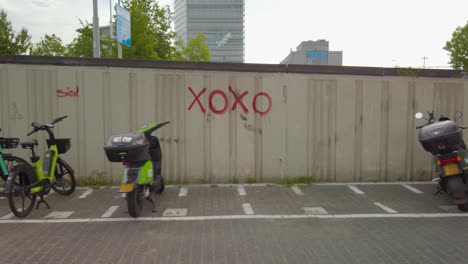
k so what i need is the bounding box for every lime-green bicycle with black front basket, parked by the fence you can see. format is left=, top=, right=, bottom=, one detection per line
left=5, top=116, right=76, bottom=218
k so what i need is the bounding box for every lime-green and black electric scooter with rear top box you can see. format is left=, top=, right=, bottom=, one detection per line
left=104, top=122, right=169, bottom=217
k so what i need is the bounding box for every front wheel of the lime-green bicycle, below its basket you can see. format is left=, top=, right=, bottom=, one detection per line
left=51, top=158, right=76, bottom=195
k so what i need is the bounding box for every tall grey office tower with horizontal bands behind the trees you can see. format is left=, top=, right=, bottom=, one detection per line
left=174, top=0, right=245, bottom=62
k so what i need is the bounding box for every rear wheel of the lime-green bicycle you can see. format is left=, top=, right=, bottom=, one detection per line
left=5, top=163, right=36, bottom=218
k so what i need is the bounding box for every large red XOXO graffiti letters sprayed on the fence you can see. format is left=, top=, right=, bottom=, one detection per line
left=188, top=86, right=272, bottom=116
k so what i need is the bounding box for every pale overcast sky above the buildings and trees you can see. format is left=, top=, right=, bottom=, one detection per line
left=0, top=0, right=468, bottom=69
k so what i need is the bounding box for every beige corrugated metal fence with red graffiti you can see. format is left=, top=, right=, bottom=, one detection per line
left=0, top=56, right=468, bottom=183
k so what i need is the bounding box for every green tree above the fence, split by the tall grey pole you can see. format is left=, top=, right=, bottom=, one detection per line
left=66, top=20, right=114, bottom=58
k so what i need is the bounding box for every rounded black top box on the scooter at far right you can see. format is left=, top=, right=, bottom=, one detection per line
left=419, top=120, right=463, bottom=155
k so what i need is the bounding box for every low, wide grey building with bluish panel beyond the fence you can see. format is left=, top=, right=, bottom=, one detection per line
left=281, top=39, right=343, bottom=66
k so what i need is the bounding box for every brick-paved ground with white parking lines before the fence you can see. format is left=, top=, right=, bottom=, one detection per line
left=0, top=183, right=468, bottom=263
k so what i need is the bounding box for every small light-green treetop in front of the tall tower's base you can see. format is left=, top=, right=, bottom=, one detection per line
left=174, top=33, right=210, bottom=61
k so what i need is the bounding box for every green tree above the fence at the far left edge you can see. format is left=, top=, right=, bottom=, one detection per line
left=0, top=9, right=31, bottom=55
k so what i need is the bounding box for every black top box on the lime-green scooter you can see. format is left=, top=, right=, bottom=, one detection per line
left=104, top=133, right=150, bottom=162
